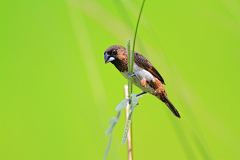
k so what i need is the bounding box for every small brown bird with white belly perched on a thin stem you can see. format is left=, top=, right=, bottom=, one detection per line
left=104, top=45, right=180, bottom=118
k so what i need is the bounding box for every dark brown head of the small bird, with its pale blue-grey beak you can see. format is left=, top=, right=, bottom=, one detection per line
left=104, top=45, right=128, bottom=64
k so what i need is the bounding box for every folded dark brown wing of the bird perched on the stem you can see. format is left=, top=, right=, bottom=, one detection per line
left=134, top=52, right=165, bottom=84
